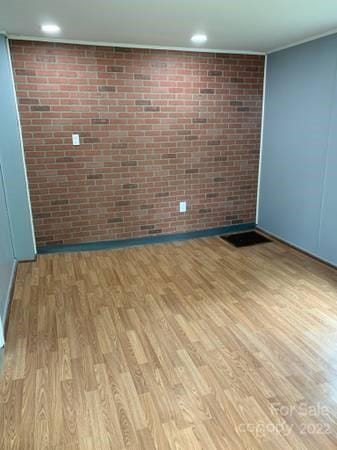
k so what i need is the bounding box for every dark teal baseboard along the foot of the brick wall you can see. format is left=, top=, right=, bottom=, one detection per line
left=37, top=222, right=255, bottom=255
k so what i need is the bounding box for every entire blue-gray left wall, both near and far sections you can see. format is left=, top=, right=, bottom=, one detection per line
left=0, top=35, right=35, bottom=347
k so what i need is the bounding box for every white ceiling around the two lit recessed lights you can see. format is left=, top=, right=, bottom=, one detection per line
left=0, top=0, right=337, bottom=52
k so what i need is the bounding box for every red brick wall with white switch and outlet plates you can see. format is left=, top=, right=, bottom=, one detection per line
left=11, top=41, right=264, bottom=245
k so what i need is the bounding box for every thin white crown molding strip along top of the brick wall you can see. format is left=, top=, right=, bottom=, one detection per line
left=7, top=34, right=266, bottom=55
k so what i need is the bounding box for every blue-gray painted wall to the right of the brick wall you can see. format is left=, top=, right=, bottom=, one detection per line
left=258, top=35, right=337, bottom=265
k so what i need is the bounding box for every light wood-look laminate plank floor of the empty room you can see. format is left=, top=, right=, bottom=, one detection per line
left=0, top=238, right=337, bottom=450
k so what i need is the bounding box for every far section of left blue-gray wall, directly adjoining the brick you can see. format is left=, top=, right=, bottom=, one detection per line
left=0, top=35, right=36, bottom=261
